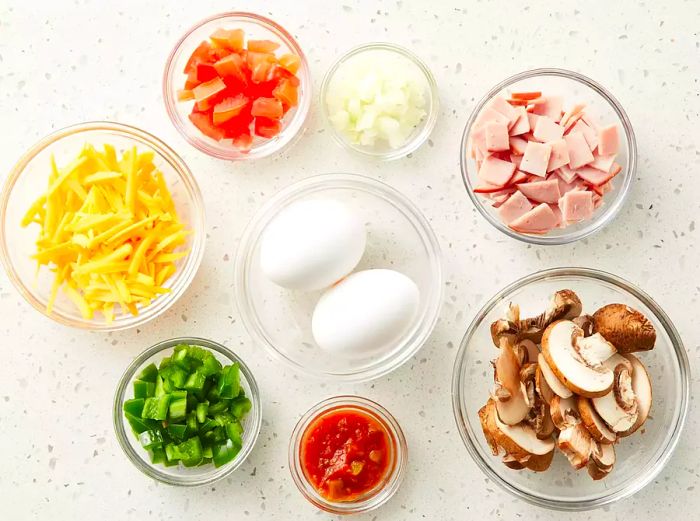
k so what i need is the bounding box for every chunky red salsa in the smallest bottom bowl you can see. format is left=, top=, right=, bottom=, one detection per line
left=301, top=409, right=392, bottom=501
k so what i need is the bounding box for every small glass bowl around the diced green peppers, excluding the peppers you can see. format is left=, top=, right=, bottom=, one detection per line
left=112, top=337, right=262, bottom=487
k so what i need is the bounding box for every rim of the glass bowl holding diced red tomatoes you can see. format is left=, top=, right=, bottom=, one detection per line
left=162, top=11, right=313, bottom=161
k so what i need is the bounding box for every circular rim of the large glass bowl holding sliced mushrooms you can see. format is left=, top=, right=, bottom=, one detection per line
left=452, top=266, right=690, bottom=512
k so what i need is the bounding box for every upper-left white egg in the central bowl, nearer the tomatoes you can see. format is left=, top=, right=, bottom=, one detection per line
left=260, top=199, right=367, bottom=291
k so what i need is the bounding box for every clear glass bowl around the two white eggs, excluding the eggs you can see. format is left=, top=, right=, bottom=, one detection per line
left=235, top=174, right=443, bottom=381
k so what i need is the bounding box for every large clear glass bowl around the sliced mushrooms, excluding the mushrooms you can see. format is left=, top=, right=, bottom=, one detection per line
left=452, top=268, right=690, bottom=510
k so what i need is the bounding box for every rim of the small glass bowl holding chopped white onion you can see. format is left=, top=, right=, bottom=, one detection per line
left=319, top=41, right=440, bottom=161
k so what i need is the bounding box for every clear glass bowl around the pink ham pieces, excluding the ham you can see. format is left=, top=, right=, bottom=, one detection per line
left=459, top=69, right=637, bottom=245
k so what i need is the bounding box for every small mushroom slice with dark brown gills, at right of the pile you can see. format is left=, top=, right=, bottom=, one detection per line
left=593, top=364, right=639, bottom=432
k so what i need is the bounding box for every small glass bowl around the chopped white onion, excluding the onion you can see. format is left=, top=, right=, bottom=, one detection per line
left=320, top=42, right=440, bottom=161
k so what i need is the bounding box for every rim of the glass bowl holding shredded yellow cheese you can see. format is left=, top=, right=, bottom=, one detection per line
left=0, top=121, right=206, bottom=332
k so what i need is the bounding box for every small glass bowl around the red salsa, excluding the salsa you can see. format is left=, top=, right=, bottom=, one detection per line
left=289, top=396, right=408, bottom=514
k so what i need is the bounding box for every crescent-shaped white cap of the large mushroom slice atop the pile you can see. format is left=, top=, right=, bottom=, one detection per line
left=542, top=320, right=614, bottom=398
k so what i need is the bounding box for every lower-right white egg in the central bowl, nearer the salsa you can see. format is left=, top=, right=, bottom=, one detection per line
left=311, top=269, right=420, bottom=355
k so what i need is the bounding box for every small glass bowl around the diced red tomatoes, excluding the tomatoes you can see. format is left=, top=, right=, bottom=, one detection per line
left=163, top=12, right=311, bottom=160
